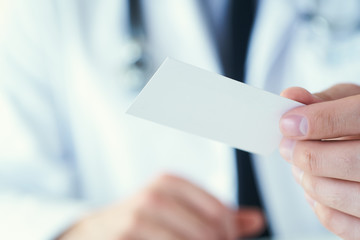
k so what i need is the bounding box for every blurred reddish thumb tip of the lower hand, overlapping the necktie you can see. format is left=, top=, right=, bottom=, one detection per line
left=233, top=208, right=265, bottom=238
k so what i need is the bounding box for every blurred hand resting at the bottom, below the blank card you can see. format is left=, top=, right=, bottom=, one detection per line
left=59, top=175, right=264, bottom=240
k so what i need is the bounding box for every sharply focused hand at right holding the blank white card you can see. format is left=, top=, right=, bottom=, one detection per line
left=280, top=84, right=360, bottom=239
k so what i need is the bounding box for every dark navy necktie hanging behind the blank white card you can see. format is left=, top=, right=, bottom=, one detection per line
left=229, top=0, right=269, bottom=236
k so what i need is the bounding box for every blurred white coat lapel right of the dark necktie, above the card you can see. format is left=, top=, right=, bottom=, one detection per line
left=246, top=0, right=296, bottom=91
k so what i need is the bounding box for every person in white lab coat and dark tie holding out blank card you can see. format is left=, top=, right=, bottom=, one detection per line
left=0, top=0, right=359, bottom=239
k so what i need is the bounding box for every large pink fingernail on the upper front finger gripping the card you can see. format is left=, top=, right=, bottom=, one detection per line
left=280, top=115, right=308, bottom=137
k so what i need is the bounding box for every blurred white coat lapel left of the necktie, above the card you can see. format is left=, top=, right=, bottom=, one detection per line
left=143, top=0, right=221, bottom=73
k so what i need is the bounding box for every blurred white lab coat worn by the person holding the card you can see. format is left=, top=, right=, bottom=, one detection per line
left=0, top=0, right=350, bottom=239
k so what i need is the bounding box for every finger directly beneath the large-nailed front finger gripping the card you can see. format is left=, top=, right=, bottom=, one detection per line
left=280, top=138, right=360, bottom=182
